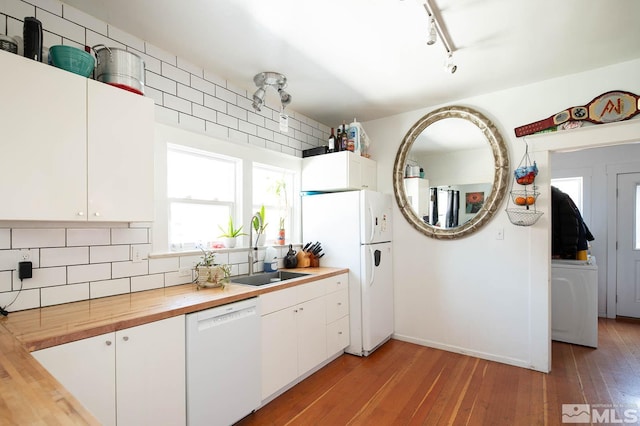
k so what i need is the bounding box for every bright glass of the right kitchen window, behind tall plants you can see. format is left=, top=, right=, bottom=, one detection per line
left=252, top=163, right=295, bottom=243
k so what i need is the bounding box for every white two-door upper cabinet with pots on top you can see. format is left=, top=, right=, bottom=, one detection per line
left=0, top=51, right=154, bottom=222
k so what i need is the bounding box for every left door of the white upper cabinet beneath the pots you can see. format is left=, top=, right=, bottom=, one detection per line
left=0, top=51, right=87, bottom=221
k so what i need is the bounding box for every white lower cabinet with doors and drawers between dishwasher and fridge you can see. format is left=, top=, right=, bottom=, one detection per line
left=260, top=274, right=349, bottom=401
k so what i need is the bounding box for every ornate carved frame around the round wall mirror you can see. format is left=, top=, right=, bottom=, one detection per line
left=393, top=106, right=510, bottom=239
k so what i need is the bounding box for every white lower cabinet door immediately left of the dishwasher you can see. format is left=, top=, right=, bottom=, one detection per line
left=116, top=315, right=186, bottom=426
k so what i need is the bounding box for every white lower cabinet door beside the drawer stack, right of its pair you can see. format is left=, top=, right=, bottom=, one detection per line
left=296, top=297, right=327, bottom=375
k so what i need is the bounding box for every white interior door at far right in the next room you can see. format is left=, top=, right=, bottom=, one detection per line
left=616, top=173, right=640, bottom=318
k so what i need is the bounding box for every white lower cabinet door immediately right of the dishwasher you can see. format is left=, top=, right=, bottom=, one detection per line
left=261, top=307, right=298, bottom=400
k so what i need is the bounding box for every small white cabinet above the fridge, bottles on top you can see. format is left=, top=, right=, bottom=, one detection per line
left=302, top=151, right=377, bottom=191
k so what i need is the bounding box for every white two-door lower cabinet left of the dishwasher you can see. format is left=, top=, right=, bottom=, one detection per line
left=32, top=315, right=186, bottom=426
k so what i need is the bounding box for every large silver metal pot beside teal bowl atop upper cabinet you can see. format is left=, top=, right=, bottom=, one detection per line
left=93, top=44, right=144, bottom=95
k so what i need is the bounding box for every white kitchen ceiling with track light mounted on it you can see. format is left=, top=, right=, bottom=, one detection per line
left=65, top=0, right=640, bottom=126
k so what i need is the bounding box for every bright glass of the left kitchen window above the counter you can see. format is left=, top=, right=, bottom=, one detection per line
left=167, top=145, right=241, bottom=251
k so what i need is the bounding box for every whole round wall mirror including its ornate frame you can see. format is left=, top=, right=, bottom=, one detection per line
left=393, top=106, right=509, bottom=239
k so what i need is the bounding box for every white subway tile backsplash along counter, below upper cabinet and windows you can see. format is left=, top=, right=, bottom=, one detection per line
left=0, top=223, right=288, bottom=312
